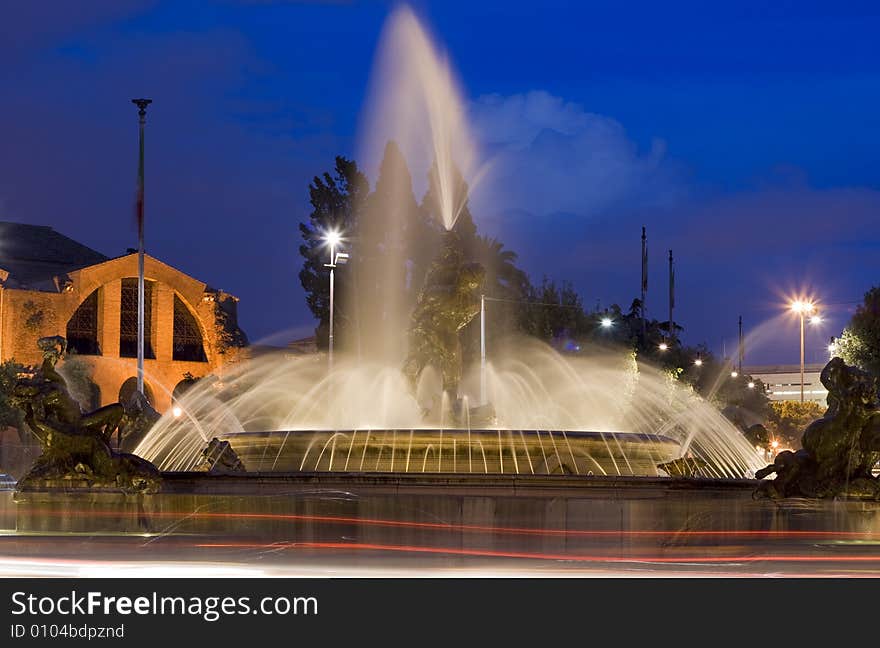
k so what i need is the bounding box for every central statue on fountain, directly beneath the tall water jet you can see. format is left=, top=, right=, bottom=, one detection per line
left=403, top=231, right=494, bottom=424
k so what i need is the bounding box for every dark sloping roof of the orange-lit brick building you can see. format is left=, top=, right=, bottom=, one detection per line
left=0, top=221, right=108, bottom=292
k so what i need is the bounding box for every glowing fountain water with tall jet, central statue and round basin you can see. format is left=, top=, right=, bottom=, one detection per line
left=130, top=8, right=760, bottom=478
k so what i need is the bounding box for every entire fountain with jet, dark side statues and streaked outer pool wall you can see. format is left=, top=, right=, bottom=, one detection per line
left=6, top=9, right=880, bottom=576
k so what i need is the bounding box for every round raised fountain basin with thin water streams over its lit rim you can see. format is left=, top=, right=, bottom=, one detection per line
left=220, top=429, right=681, bottom=476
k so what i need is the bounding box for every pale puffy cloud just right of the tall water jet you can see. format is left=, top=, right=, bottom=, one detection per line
left=470, top=90, right=685, bottom=219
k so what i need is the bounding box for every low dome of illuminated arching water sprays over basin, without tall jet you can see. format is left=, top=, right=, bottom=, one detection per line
left=135, top=341, right=761, bottom=477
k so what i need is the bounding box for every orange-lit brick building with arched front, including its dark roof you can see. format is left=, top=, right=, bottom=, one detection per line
left=0, top=222, right=247, bottom=412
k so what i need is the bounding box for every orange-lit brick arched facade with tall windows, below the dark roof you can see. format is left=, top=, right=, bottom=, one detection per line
left=0, top=254, right=243, bottom=412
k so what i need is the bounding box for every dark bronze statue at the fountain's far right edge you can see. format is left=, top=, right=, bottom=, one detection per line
left=755, top=358, right=880, bottom=499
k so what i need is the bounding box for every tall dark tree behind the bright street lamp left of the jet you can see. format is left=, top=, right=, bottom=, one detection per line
left=299, top=156, right=369, bottom=349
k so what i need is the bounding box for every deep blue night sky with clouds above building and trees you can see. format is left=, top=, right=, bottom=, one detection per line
left=0, top=0, right=880, bottom=364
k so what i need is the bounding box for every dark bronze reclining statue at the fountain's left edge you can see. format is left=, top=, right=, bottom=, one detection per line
left=11, top=336, right=160, bottom=491
